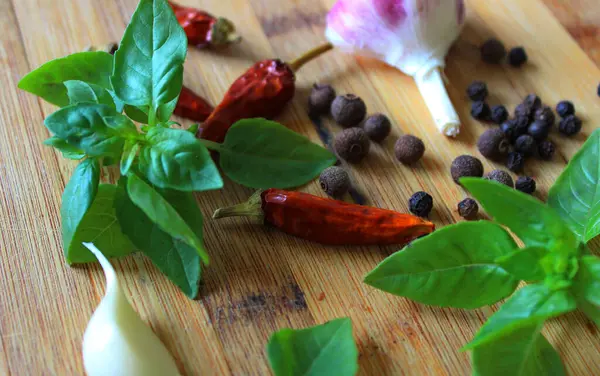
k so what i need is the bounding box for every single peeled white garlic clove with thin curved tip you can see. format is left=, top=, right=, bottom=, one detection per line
left=83, top=243, right=180, bottom=376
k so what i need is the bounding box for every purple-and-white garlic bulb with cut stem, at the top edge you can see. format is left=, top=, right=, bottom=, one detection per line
left=325, top=0, right=465, bottom=136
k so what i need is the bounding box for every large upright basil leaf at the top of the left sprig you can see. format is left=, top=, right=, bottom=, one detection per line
left=111, top=0, right=187, bottom=125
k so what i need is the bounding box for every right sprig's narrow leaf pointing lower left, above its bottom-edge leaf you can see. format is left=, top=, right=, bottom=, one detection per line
left=463, top=284, right=576, bottom=350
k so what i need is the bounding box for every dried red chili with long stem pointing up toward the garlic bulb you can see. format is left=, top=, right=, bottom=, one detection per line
left=197, top=43, right=332, bottom=142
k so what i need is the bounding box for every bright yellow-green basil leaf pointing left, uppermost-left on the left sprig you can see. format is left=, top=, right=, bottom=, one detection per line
left=19, top=51, right=113, bottom=107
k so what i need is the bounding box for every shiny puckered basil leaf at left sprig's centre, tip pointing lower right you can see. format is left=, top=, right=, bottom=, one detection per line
left=139, top=127, right=223, bottom=192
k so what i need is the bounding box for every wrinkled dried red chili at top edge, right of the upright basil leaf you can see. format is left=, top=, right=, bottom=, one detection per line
left=169, top=1, right=242, bottom=48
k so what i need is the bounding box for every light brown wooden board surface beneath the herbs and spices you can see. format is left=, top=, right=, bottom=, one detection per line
left=0, top=0, right=600, bottom=375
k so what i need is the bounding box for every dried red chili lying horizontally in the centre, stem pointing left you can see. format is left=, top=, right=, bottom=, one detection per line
left=213, top=188, right=435, bottom=245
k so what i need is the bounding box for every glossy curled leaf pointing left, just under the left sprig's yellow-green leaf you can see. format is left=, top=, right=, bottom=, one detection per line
left=44, top=103, right=124, bottom=160
